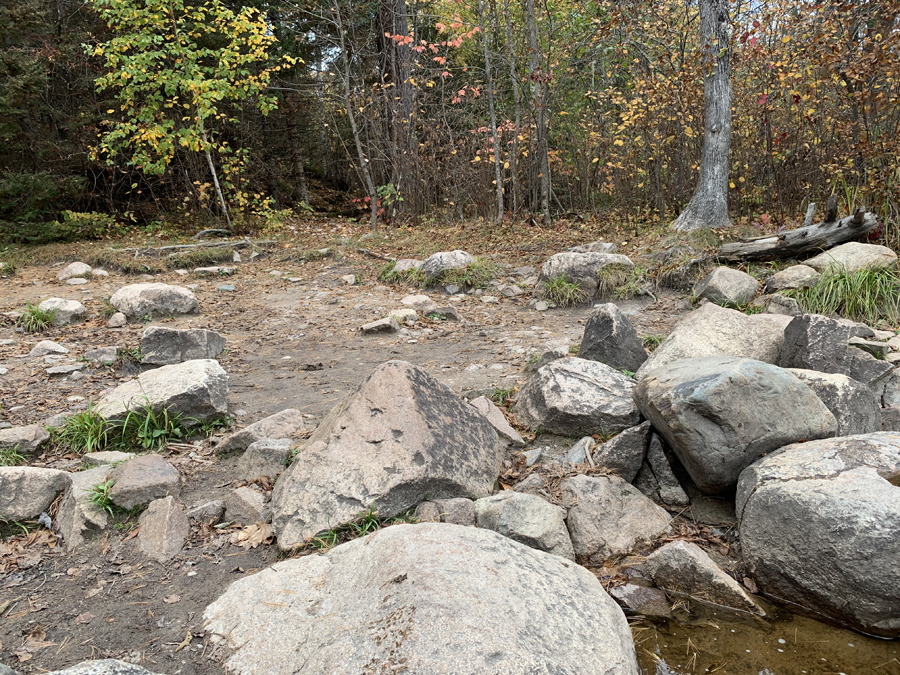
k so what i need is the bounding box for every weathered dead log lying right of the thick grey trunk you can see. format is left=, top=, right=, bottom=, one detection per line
left=716, top=211, right=878, bottom=262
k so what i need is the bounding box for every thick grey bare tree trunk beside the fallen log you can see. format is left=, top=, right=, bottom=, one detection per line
left=672, top=0, right=731, bottom=232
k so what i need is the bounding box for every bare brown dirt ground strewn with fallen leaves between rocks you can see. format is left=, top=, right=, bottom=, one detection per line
left=0, top=219, right=687, bottom=675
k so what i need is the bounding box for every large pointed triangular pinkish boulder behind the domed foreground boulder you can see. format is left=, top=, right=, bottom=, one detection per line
left=272, top=361, right=500, bottom=549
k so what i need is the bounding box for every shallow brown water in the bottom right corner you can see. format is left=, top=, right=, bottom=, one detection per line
left=632, top=603, right=900, bottom=675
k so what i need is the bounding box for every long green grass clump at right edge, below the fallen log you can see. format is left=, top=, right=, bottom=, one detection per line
left=785, top=267, right=900, bottom=326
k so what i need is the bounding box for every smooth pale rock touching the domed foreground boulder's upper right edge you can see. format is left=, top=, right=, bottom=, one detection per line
left=475, top=490, right=575, bottom=560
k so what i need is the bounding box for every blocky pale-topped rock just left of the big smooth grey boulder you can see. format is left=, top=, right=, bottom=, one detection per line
left=516, top=357, right=641, bottom=436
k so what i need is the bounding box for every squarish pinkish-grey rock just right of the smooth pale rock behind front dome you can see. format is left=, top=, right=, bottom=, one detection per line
left=559, top=475, right=671, bottom=566
